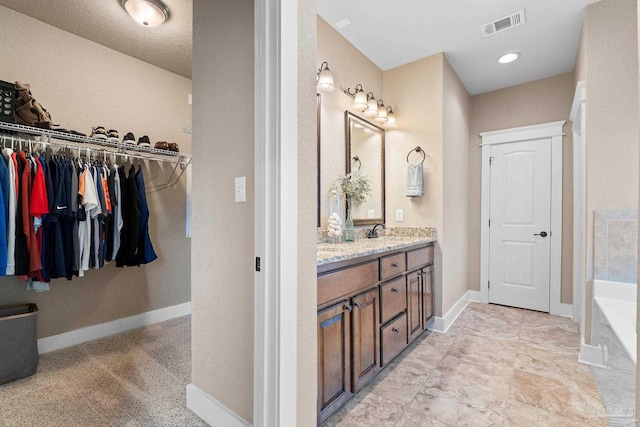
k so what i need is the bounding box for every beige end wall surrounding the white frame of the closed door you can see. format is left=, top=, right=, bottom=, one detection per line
left=469, top=73, right=575, bottom=304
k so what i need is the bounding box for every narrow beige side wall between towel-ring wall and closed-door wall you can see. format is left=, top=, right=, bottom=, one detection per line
left=439, top=58, right=471, bottom=314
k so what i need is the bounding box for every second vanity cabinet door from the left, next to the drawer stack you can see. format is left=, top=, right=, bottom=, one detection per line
left=351, top=288, right=380, bottom=393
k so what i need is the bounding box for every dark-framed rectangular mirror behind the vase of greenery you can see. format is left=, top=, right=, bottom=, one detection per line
left=345, top=111, right=385, bottom=225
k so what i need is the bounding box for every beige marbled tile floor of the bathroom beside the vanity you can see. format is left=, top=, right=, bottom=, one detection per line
left=323, top=303, right=609, bottom=427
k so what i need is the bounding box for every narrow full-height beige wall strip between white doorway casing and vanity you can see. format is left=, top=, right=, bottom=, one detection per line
left=296, top=0, right=320, bottom=426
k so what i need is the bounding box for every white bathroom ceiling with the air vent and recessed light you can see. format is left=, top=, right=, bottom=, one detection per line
left=318, top=0, right=597, bottom=95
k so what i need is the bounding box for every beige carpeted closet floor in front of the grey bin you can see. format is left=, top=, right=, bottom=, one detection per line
left=0, top=317, right=206, bottom=427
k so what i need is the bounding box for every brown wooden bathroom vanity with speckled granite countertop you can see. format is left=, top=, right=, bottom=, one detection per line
left=318, top=237, right=435, bottom=425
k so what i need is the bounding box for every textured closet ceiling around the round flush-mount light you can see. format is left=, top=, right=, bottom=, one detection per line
left=0, top=0, right=193, bottom=79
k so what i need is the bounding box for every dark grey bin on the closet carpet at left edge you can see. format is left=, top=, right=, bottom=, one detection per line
left=0, top=304, right=39, bottom=384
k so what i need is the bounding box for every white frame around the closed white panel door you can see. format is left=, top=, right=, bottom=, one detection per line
left=480, top=120, right=572, bottom=317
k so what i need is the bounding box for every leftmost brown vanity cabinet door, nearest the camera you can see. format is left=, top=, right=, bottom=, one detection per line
left=318, top=301, right=353, bottom=424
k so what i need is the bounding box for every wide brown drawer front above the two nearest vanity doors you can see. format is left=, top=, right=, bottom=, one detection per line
left=318, top=260, right=378, bottom=305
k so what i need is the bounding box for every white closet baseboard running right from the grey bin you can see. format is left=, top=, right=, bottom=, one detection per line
left=38, top=302, right=191, bottom=354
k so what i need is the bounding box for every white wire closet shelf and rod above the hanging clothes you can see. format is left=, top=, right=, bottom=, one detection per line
left=0, top=122, right=192, bottom=185
